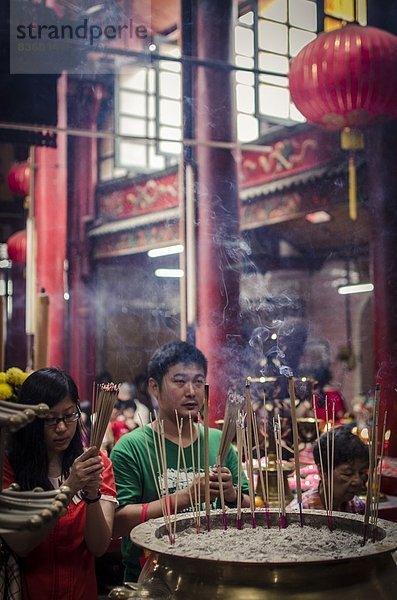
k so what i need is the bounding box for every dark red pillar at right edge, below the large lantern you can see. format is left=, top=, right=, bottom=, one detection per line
left=367, top=121, right=397, bottom=460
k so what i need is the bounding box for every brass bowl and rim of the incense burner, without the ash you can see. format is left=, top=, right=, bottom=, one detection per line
left=110, top=510, right=397, bottom=600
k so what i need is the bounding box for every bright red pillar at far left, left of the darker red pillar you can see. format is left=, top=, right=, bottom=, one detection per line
left=34, top=75, right=67, bottom=367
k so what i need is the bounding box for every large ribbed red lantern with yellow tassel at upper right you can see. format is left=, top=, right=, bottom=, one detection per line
left=289, top=25, right=397, bottom=219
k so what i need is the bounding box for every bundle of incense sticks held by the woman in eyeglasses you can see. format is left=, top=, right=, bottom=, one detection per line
left=90, top=383, right=119, bottom=449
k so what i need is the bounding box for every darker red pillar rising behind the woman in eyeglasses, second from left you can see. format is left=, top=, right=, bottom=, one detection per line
left=68, top=81, right=102, bottom=399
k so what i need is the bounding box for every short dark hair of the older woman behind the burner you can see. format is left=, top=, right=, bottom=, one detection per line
left=313, top=427, right=369, bottom=468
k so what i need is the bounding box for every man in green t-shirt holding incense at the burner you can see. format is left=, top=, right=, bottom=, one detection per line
left=111, top=341, right=249, bottom=581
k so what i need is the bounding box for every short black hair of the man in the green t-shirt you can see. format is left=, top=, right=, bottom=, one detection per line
left=148, top=340, right=208, bottom=385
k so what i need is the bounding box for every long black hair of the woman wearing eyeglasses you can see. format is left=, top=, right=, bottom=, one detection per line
left=7, top=367, right=83, bottom=490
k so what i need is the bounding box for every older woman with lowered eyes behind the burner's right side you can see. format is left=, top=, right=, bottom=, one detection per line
left=288, top=427, right=369, bottom=515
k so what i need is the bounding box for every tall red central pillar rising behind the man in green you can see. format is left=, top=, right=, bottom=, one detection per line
left=195, top=0, right=241, bottom=424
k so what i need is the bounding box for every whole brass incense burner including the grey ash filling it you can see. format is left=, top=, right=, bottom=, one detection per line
left=123, top=510, right=397, bottom=600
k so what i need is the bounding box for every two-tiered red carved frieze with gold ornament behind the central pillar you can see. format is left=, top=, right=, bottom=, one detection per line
left=94, top=130, right=340, bottom=258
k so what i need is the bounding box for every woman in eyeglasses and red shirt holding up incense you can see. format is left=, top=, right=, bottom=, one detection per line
left=3, top=367, right=117, bottom=600
